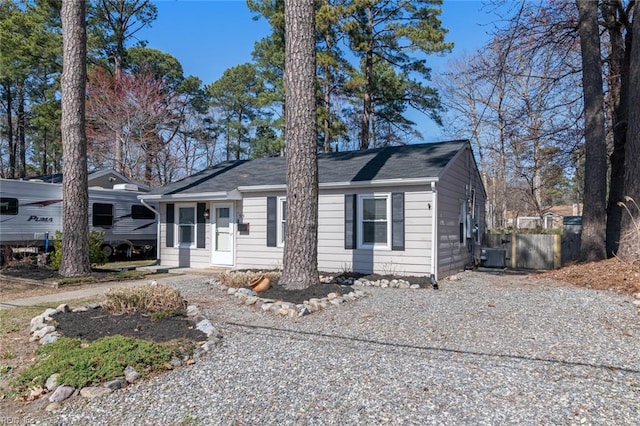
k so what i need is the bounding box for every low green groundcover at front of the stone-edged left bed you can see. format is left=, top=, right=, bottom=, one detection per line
left=13, top=335, right=193, bottom=392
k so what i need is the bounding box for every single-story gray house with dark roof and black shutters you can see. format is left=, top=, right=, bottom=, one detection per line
left=139, top=140, right=486, bottom=279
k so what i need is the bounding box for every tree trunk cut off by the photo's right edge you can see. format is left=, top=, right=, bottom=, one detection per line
left=618, top=10, right=640, bottom=260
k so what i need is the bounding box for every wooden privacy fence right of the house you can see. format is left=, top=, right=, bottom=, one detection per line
left=484, top=226, right=580, bottom=269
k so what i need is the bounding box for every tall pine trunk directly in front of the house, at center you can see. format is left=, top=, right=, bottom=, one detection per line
left=280, top=0, right=318, bottom=289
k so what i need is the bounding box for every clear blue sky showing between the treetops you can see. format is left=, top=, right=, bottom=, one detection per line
left=136, top=0, right=502, bottom=140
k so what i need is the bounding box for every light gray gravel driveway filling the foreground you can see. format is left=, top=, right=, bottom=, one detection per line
left=45, top=272, right=640, bottom=425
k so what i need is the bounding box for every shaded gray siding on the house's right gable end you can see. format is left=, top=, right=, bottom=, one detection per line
left=437, top=150, right=485, bottom=278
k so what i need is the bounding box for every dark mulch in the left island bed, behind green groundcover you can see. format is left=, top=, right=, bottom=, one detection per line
left=53, top=308, right=207, bottom=342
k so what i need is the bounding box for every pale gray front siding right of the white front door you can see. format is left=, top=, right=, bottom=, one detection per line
left=236, top=187, right=433, bottom=275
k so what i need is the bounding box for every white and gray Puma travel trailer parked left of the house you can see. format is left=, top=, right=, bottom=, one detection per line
left=0, top=179, right=157, bottom=257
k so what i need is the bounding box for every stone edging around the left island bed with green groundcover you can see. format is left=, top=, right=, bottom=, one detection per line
left=29, top=303, right=222, bottom=411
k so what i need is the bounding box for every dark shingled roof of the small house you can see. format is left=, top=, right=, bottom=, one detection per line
left=149, top=140, right=469, bottom=195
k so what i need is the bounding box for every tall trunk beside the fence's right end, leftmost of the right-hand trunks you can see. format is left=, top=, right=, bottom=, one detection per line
left=576, top=0, right=607, bottom=261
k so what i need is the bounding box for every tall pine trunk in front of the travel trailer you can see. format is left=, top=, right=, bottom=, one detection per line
left=60, top=0, right=91, bottom=277
